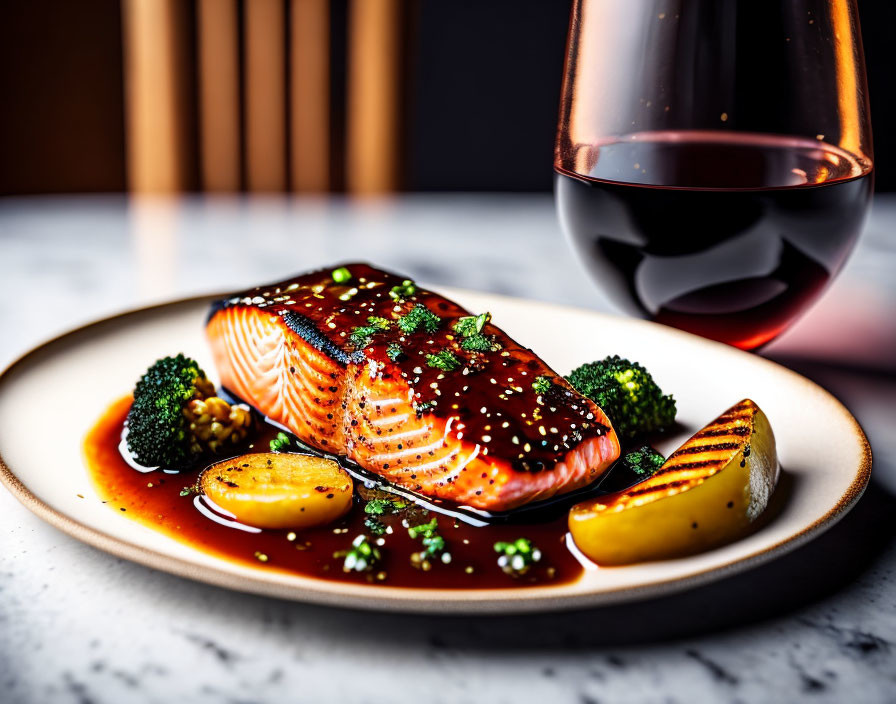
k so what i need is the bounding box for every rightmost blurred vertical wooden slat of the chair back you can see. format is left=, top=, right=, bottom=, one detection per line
left=346, top=0, right=402, bottom=195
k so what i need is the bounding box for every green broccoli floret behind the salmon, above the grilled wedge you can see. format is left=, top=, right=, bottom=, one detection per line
left=566, top=355, right=675, bottom=440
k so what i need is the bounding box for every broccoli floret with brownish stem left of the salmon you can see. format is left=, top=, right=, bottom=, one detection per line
left=127, top=354, right=252, bottom=469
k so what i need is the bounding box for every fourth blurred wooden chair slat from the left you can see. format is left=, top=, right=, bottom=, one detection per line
left=289, top=0, right=330, bottom=192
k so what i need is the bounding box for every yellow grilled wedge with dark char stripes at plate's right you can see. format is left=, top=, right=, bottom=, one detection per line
left=569, top=399, right=780, bottom=565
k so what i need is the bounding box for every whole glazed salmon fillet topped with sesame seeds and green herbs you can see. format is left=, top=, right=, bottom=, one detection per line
left=206, top=263, right=619, bottom=511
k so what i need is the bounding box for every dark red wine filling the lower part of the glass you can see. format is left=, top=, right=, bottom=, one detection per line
left=556, top=131, right=872, bottom=349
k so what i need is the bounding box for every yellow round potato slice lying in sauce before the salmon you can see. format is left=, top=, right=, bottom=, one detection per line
left=199, top=452, right=352, bottom=529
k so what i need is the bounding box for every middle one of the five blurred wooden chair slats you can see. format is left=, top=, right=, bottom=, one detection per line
left=243, top=0, right=286, bottom=191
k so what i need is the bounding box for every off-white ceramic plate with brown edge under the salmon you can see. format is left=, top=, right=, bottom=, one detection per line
left=0, top=291, right=871, bottom=613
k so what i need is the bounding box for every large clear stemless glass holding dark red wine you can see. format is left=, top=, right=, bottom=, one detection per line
left=554, top=0, right=873, bottom=349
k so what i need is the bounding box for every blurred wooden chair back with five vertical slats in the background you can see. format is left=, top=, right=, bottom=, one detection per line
left=122, top=0, right=408, bottom=195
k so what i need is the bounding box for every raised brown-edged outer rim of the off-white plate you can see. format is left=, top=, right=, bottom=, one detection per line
left=0, top=286, right=872, bottom=615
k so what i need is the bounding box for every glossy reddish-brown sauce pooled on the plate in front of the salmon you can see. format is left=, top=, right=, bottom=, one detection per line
left=84, top=397, right=583, bottom=589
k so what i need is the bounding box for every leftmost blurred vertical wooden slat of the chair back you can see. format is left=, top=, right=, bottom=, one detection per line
left=122, top=0, right=189, bottom=193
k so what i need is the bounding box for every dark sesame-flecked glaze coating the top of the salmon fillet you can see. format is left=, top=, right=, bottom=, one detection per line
left=210, top=263, right=608, bottom=484
